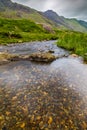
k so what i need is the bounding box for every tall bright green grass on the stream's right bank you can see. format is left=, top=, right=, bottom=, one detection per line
left=57, top=31, right=87, bottom=61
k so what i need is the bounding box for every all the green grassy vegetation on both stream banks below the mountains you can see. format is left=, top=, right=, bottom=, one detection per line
left=0, top=19, right=87, bottom=61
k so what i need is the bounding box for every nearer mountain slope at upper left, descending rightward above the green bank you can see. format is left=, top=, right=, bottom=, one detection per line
left=0, top=0, right=54, bottom=26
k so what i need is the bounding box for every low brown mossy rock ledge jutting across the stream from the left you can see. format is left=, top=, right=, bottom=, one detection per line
left=0, top=52, right=56, bottom=65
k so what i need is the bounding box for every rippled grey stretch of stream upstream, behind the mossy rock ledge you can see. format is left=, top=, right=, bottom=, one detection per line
left=0, top=41, right=68, bottom=56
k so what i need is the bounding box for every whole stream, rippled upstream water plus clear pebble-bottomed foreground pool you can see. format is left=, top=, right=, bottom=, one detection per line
left=0, top=41, right=87, bottom=130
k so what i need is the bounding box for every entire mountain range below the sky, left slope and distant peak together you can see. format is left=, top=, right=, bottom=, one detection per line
left=0, top=0, right=87, bottom=32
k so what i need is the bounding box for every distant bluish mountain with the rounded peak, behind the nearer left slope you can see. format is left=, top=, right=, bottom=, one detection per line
left=43, top=10, right=87, bottom=32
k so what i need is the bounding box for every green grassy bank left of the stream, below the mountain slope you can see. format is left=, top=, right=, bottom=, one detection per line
left=0, top=19, right=57, bottom=44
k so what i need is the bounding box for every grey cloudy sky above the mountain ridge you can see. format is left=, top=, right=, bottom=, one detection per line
left=12, top=0, right=87, bottom=21
